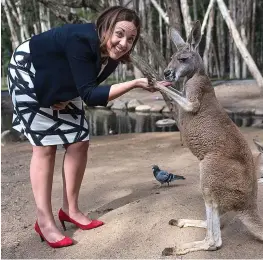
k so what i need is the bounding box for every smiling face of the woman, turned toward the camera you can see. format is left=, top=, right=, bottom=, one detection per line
left=106, top=21, right=137, bottom=60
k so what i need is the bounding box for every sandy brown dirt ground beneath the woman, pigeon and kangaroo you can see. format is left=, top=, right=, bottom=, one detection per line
left=1, top=80, right=263, bottom=259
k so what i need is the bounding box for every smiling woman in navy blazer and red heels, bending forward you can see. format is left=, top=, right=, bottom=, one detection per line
left=8, top=6, right=171, bottom=248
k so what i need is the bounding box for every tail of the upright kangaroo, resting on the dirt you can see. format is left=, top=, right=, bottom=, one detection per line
left=238, top=209, right=263, bottom=242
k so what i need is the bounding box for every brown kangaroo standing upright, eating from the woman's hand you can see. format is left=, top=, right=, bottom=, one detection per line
left=154, top=21, right=263, bottom=255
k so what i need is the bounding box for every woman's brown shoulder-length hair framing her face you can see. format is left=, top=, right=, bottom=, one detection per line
left=96, top=6, right=141, bottom=63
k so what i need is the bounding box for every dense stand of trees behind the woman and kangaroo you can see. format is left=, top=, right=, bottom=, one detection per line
left=1, top=0, right=263, bottom=92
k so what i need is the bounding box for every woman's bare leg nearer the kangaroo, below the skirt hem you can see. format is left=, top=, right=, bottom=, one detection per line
left=62, top=141, right=91, bottom=225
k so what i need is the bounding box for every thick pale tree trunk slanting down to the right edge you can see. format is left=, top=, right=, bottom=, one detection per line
left=217, top=0, right=263, bottom=95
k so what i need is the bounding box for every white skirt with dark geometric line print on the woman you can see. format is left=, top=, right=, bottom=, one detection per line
left=7, top=40, right=89, bottom=146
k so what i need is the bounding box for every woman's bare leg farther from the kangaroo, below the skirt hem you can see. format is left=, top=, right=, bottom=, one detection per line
left=30, top=145, right=65, bottom=242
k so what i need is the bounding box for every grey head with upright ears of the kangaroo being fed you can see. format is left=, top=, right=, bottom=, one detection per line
left=164, top=21, right=204, bottom=81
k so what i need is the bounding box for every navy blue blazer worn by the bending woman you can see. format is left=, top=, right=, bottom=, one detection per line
left=29, top=23, right=119, bottom=107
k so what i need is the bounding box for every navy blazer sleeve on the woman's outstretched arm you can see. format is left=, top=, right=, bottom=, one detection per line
left=65, top=34, right=110, bottom=106
